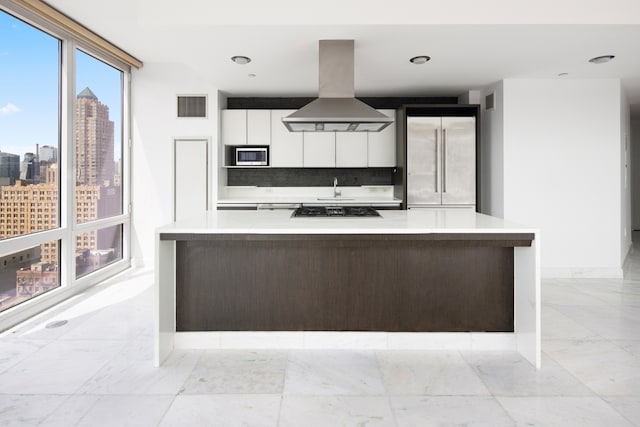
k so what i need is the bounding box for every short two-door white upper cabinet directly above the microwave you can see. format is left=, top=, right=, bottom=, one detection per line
left=222, top=110, right=271, bottom=145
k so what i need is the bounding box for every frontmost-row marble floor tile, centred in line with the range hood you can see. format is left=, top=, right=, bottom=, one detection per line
left=278, top=396, right=396, bottom=427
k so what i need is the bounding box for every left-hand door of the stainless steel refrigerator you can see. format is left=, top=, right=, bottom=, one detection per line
left=407, top=117, right=442, bottom=205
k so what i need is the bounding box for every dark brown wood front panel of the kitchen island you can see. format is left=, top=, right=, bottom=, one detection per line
left=168, top=233, right=534, bottom=332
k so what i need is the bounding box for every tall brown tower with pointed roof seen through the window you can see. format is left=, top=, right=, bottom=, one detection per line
left=76, top=87, right=115, bottom=186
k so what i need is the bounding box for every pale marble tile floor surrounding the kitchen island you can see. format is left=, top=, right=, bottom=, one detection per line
left=0, top=244, right=640, bottom=427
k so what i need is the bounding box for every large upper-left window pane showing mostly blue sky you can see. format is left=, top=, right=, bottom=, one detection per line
left=0, top=12, right=61, bottom=244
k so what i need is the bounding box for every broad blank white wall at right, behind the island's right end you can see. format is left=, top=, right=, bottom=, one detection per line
left=503, top=79, right=622, bottom=277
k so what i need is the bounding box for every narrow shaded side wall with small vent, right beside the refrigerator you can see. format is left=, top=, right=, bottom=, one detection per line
left=480, top=82, right=504, bottom=218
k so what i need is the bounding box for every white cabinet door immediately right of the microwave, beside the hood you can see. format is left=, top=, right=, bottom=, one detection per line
left=269, top=110, right=303, bottom=168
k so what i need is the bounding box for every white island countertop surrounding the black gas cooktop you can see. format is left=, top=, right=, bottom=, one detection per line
left=157, top=208, right=538, bottom=234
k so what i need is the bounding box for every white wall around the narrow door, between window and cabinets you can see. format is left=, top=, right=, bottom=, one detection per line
left=131, top=62, right=218, bottom=266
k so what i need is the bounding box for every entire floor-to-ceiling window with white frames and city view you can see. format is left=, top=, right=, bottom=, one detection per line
left=0, top=2, right=130, bottom=320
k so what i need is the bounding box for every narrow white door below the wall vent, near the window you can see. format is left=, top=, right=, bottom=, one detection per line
left=173, top=139, right=209, bottom=221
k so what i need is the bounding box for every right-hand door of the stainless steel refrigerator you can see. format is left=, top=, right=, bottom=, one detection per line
left=441, top=117, right=476, bottom=205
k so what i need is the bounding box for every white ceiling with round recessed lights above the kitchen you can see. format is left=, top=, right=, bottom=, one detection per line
left=48, top=0, right=640, bottom=117
